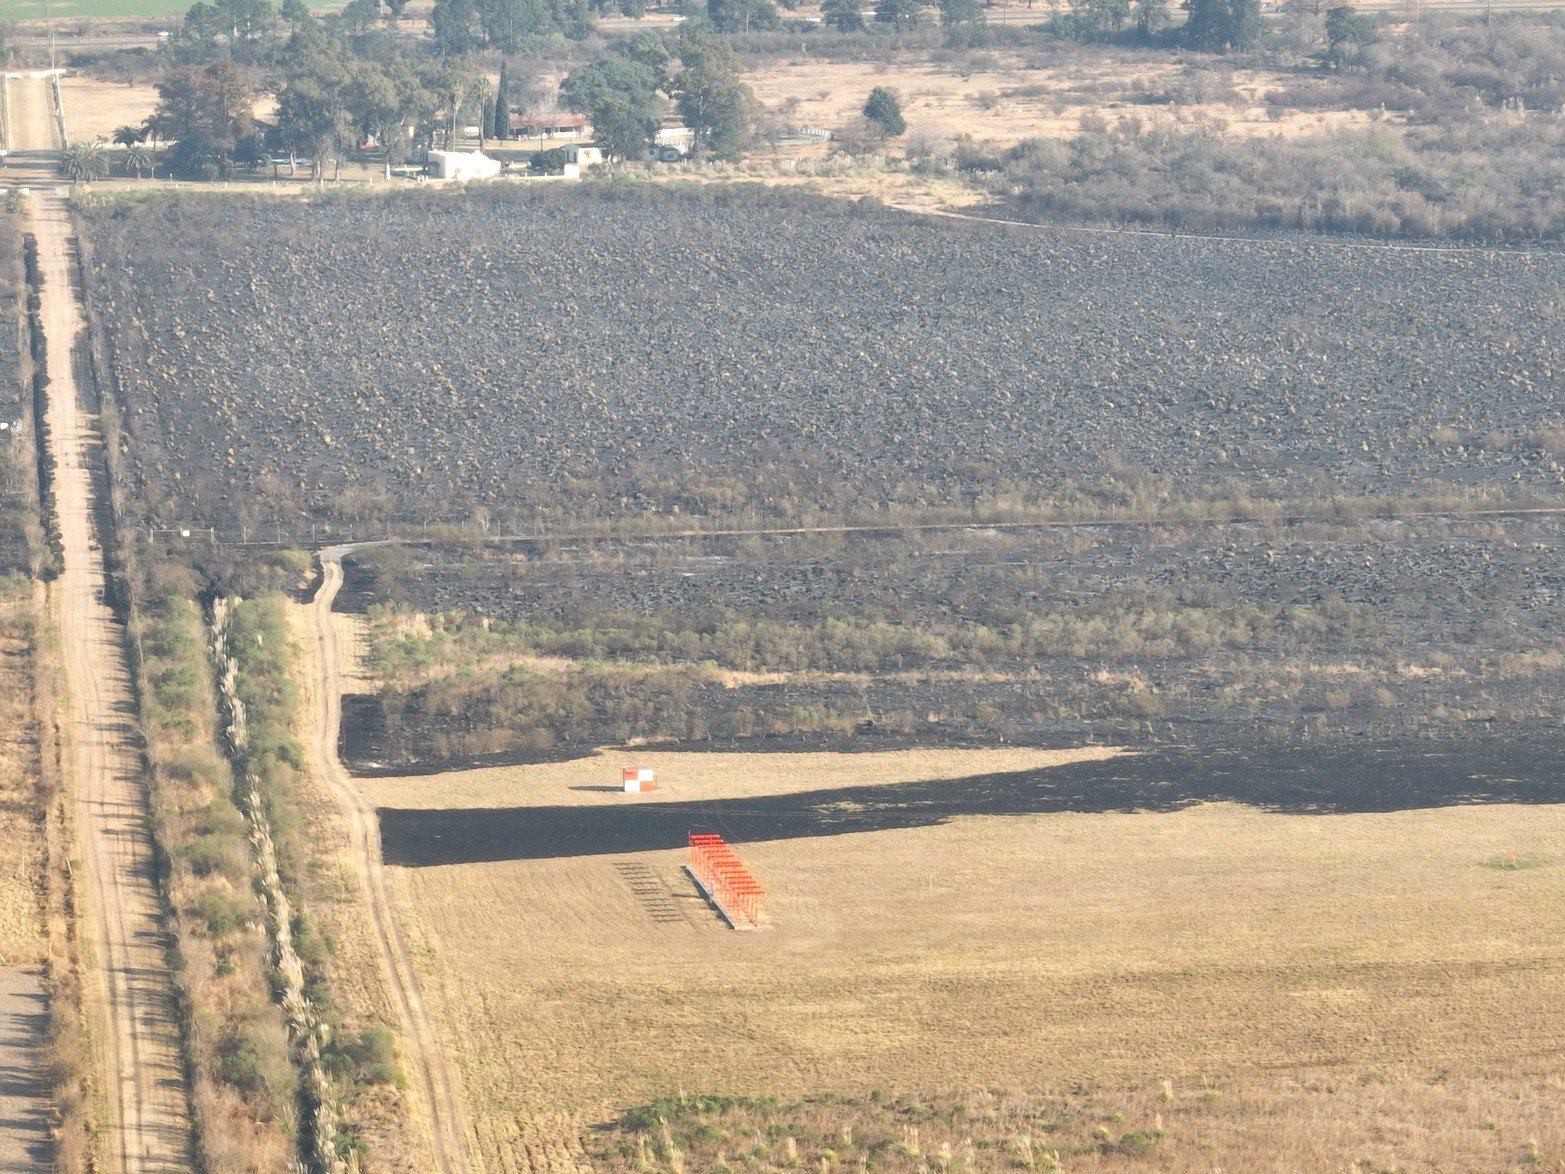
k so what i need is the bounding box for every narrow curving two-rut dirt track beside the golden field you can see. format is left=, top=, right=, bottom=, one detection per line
left=311, top=546, right=473, bottom=1174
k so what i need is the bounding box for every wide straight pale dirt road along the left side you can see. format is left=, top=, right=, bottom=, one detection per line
left=11, top=78, right=192, bottom=1174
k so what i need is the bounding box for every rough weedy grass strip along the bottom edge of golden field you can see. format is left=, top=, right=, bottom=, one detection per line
left=588, top=1072, right=1565, bottom=1174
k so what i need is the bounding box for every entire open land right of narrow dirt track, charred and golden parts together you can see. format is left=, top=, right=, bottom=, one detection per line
left=85, top=185, right=1565, bottom=1171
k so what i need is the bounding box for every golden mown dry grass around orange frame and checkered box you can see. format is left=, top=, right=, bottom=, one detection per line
left=363, top=748, right=1565, bottom=1169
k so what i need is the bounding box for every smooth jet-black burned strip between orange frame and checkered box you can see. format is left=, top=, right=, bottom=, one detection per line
left=380, top=737, right=1565, bottom=867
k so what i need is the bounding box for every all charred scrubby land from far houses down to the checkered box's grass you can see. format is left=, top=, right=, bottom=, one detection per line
left=76, top=186, right=1565, bottom=806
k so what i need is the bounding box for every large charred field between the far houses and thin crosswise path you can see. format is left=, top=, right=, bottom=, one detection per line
left=79, top=188, right=1565, bottom=537
